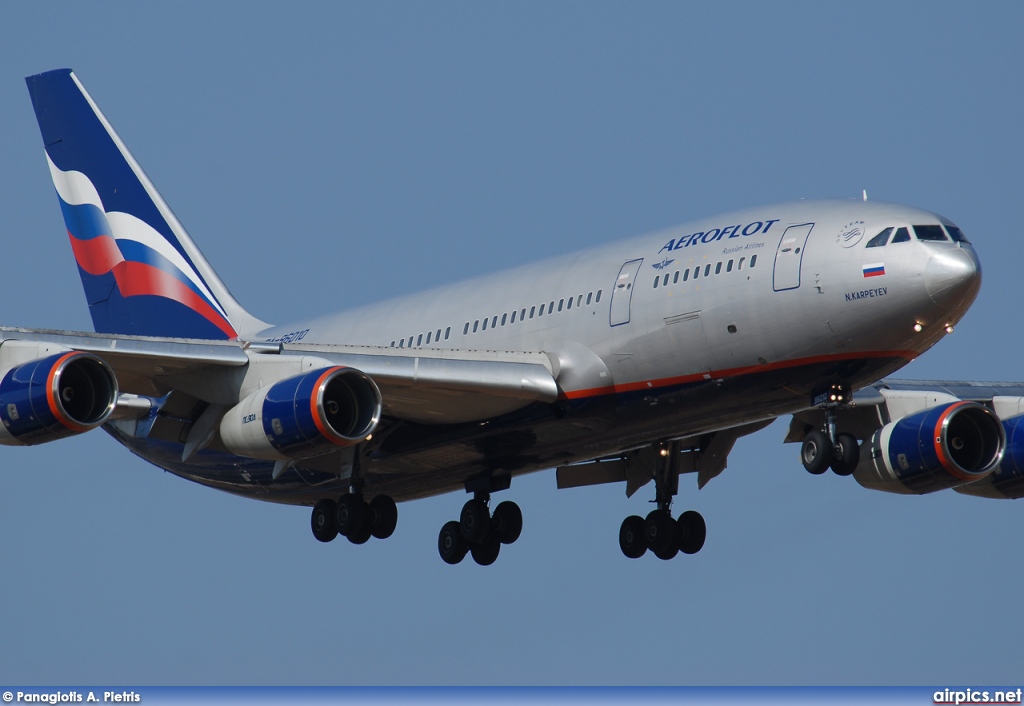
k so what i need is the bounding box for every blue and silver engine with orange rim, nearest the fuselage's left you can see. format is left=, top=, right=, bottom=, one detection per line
left=220, top=366, right=382, bottom=461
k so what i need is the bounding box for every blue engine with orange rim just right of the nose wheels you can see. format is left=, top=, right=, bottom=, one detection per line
left=853, top=402, right=1006, bottom=494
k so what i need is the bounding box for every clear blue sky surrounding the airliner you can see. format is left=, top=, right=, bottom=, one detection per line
left=0, top=2, right=1024, bottom=686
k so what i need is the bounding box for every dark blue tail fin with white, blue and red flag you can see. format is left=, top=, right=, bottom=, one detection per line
left=26, top=69, right=266, bottom=339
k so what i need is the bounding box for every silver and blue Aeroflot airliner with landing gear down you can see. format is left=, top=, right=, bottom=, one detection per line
left=8, top=69, right=1024, bottom=565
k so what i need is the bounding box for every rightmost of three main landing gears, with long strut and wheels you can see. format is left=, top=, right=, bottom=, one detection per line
left=618, top=442, right=708, bottom=560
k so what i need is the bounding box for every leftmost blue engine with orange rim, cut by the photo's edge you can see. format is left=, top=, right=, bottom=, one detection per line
left=0, top=351, right=118, bottom=446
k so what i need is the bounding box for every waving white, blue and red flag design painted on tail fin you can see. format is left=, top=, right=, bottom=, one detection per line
left=46, top=155, right=237, bottom=338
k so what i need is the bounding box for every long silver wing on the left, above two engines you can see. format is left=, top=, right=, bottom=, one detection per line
left=0, top=328, right=559, bottom=424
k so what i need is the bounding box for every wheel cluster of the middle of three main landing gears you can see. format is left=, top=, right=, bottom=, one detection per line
left=437, top=491, right=522, bottom=567
